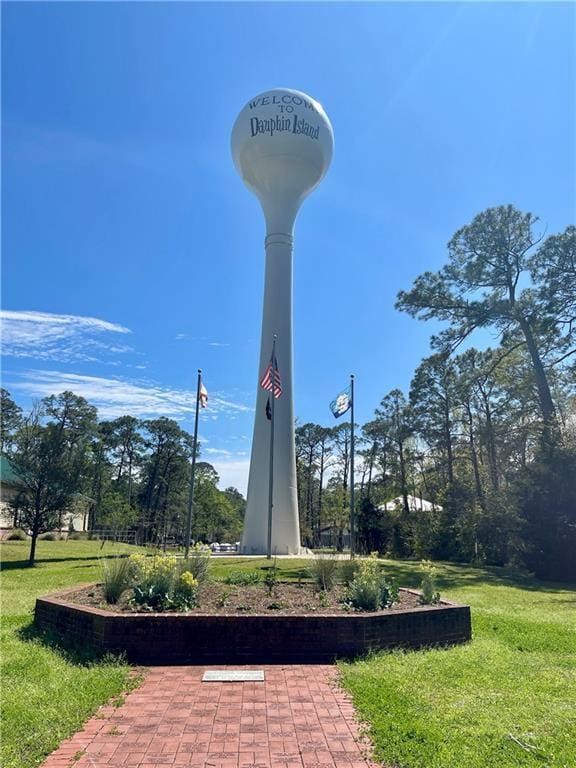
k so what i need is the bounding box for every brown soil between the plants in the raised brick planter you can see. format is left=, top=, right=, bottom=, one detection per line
left=66, top=582, right=430, bottom=616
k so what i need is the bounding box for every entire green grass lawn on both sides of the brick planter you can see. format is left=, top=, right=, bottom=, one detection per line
left=1, top=541, right=576, bottom=768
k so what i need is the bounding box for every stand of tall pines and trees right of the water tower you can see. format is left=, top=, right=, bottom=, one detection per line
left=296, top=206, right=576, bottom=579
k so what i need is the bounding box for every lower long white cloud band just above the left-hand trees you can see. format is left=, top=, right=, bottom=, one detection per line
left=6, top=370, right=253, bottom=419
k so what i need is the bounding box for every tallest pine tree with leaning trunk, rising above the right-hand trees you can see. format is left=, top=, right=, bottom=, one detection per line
left=396, top=205, right=555, bottom=426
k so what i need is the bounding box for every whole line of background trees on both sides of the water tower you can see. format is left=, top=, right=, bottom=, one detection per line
left=1, top=206, right=576, bottom=580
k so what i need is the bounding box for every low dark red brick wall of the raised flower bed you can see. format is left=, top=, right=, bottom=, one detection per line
left=35, top=590, right=472, bottom=664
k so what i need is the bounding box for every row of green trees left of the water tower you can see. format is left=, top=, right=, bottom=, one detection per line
left=0, top=389, right=245, bottom=564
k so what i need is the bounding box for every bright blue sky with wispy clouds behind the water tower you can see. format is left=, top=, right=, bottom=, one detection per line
left=2, top=3, right=576, bottom=490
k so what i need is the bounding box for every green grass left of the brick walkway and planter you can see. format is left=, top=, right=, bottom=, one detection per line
left=0, top=541, right=144, bottom=768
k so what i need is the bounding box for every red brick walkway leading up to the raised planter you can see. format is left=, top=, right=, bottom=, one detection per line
left=44, top=665, right=380, bottom=768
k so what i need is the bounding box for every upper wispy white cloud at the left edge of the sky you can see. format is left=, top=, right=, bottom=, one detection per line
left=0, top=310, right=132, bottom=362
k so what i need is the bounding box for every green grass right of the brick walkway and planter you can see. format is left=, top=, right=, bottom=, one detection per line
left=340, top=563, right=576, bottom=768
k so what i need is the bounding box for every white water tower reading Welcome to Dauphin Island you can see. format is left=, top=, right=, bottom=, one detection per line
left=232, top=88, right=334, bottom=555
